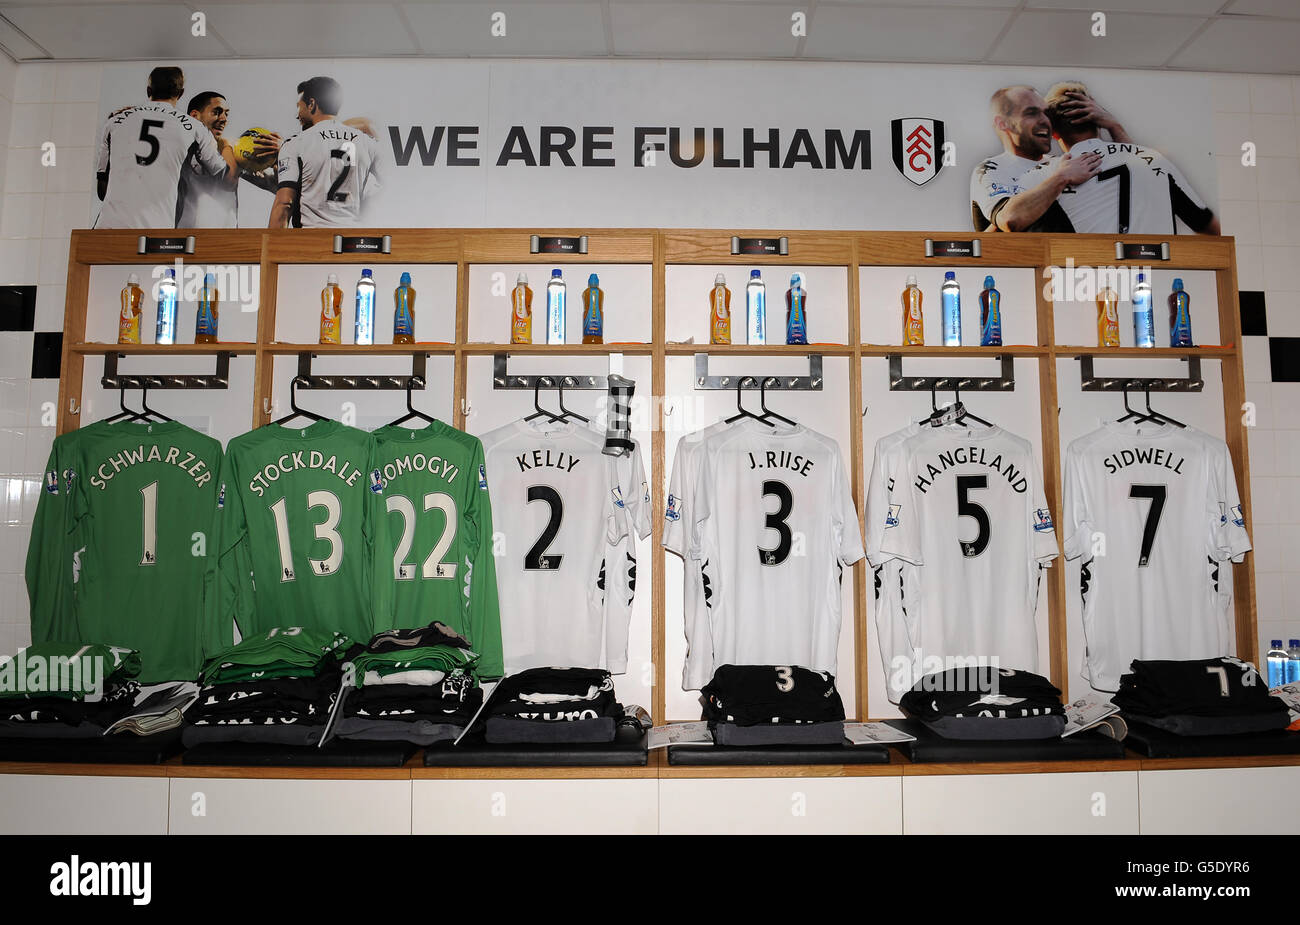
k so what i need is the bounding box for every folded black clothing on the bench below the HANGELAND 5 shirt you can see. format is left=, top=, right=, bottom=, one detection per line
left=898, top=665, right=1065, bottom=720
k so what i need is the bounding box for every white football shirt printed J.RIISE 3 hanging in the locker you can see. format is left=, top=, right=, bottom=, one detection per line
left=681, top=418, right=863, bottom=674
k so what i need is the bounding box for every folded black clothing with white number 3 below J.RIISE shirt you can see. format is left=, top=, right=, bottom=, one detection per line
left=701, top=665, right=844, bottom=726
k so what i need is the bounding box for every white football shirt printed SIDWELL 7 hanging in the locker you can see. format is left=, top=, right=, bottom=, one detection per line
left=1065, top=421, right=1251, bottom=691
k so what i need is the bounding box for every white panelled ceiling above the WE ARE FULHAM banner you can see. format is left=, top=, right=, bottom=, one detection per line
left=0, top=0, right=1300, bottom=74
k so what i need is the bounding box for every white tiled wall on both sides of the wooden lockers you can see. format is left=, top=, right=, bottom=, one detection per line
left=0, top=53, right=1300, bottom=691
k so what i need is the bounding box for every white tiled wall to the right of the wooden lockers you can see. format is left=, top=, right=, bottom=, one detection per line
left=1213, top=75, right=1300, bottom=653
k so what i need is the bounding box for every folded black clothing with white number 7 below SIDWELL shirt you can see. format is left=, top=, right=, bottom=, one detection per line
left=1113, top=656, right=1287, bottom=716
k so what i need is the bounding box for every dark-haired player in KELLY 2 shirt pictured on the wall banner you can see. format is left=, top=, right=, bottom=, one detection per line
left=269, top=77, right=381, bottom=229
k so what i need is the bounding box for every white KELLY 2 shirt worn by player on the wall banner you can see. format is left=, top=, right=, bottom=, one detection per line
left=276, top=120, right=381, bottom=227
